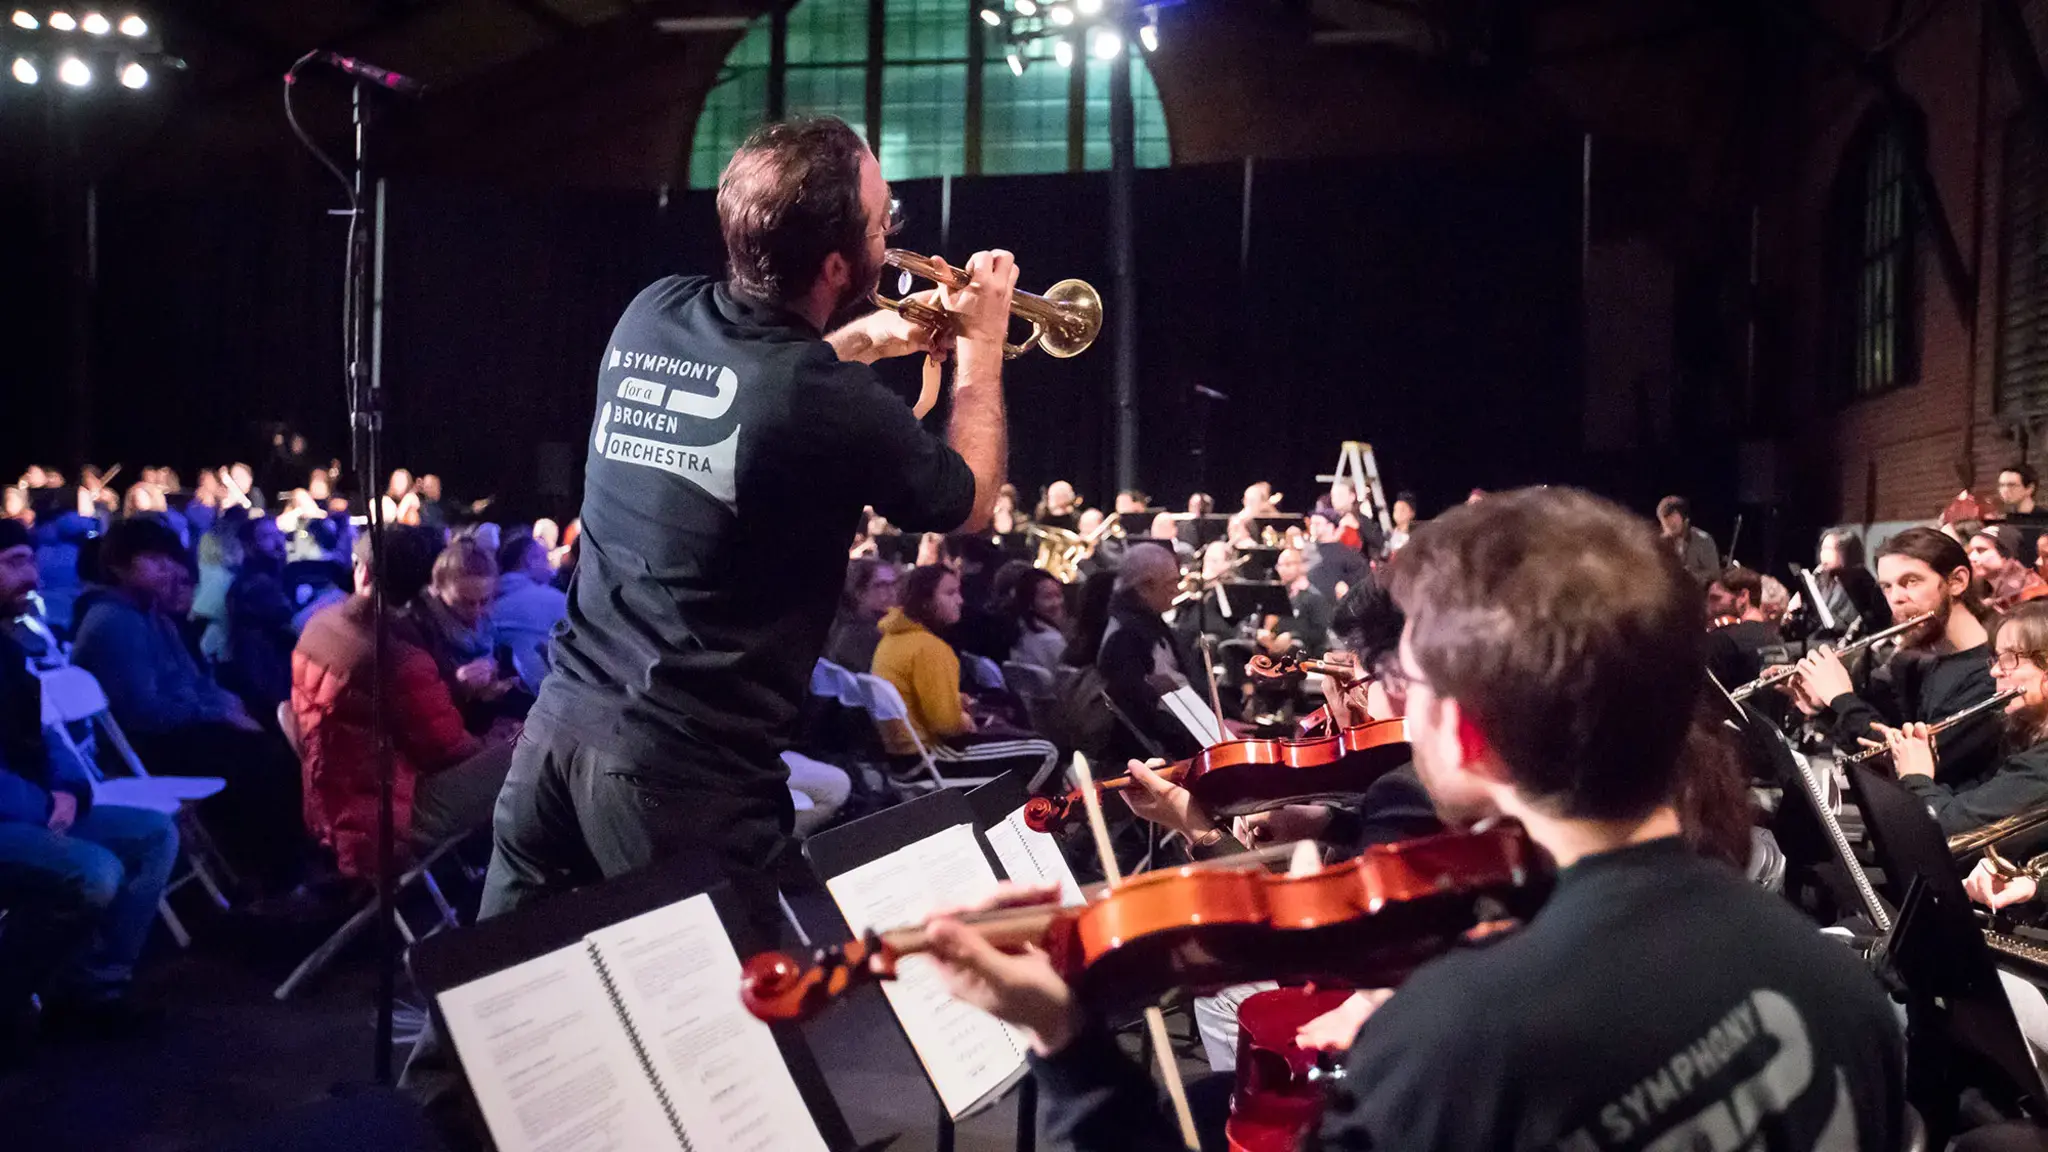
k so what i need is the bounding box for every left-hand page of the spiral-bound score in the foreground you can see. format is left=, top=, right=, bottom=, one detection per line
left=440, top=943, right=676, bottom=1152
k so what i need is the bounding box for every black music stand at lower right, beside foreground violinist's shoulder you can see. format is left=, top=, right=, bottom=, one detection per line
left=1849, top=765, right=2048, bottom=1148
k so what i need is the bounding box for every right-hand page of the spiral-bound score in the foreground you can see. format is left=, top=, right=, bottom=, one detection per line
left=584, top=896, right=825, bottom=1152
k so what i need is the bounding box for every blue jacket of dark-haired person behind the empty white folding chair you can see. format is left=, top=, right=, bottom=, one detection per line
left=72, top=588, right=238, bottom=734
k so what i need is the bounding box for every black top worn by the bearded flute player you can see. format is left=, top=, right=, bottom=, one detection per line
left=1825, top=644, right=1999, bottom=785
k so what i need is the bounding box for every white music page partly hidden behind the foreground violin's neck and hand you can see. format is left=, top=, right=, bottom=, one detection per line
left=825, top=824, right=1026, bottom=1119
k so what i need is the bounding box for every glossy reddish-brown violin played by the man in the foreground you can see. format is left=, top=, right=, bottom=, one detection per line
left=739, top=822, right=1542, bottom=1023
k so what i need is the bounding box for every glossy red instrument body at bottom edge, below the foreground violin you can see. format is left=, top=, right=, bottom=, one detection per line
left=1223, top=988, right=1352, bottom=1152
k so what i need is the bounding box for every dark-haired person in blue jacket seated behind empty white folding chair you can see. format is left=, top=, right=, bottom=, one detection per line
left=72, top=519, right=305, bottom=894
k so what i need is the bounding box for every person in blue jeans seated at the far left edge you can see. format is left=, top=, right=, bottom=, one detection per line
left=0, top=521, right=178, bottom=1066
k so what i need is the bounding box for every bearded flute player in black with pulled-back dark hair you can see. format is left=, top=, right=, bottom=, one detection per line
left=1792, top=529, right=1997, bottom=785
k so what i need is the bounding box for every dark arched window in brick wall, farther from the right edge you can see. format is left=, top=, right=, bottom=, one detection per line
left=1829, top=115, right=1919, bottom=398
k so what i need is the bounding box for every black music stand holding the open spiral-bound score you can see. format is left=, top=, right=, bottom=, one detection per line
left=406, top=853, right=856, bottom=1152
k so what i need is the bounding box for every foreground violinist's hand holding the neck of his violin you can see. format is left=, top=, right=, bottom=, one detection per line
left=926, top=883, right=1081, bottom=1056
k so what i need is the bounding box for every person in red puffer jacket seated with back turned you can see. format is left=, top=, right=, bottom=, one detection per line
left=291, top=525, right=520, bottom=879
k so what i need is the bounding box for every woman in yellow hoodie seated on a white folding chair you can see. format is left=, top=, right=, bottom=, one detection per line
left=872, top=566, right=1059, bottom=791
